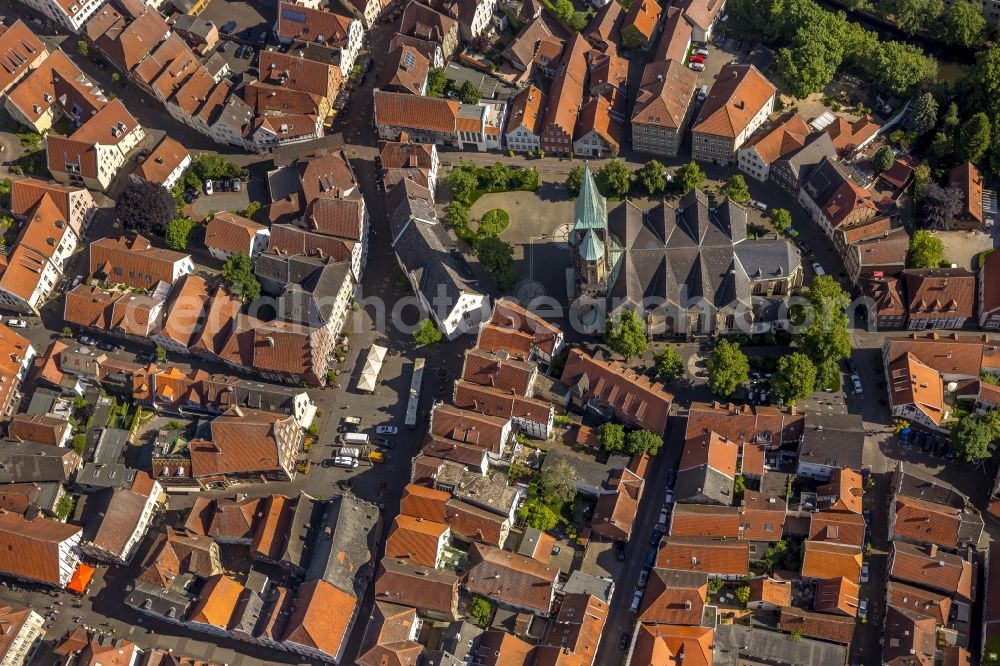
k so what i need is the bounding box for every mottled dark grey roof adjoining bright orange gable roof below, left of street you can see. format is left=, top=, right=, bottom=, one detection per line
left=305, top=495, right=379, bottom=599
